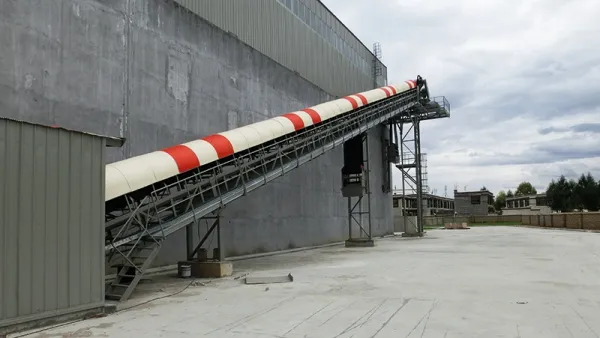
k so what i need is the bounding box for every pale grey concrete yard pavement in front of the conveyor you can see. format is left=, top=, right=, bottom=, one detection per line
left=16, top=227, right=600, bottom=338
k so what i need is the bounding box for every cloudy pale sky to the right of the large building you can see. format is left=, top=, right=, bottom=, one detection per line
left=322, top=0, right=600, bottom=196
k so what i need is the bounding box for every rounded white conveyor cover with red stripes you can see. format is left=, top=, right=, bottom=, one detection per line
left=105, top=80, right=417, bottom=201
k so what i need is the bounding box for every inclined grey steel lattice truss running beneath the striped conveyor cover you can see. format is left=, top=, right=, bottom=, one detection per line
left=105, top=77, right=446, bottom=300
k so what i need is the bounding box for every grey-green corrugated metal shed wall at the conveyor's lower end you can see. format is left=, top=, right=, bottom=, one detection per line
left=0, top=118, right=106, bottom=328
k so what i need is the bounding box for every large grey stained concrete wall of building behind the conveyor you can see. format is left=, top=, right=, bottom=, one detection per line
left=0, top=0, right=393, bottom=264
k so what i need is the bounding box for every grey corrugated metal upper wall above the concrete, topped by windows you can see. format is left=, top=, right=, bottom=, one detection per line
left=175, top=0, right=387, bottom=96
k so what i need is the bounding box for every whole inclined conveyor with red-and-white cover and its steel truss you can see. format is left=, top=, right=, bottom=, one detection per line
left=105, top=77, right=449, bottom=300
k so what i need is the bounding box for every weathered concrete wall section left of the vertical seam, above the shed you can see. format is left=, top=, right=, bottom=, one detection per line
left=0, top=0, right=125, bottom=156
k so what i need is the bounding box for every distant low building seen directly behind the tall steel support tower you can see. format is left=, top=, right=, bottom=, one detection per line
left=392, top=194, right=454, bottom=216
